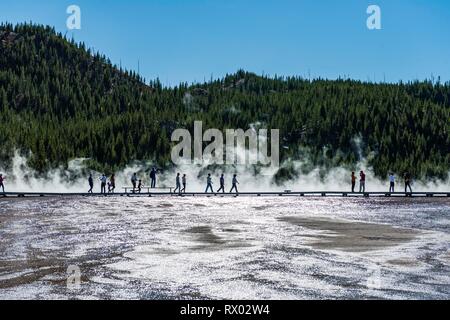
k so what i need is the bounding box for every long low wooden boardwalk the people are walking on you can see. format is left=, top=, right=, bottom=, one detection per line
left=0, top=191, right=450, bottom=199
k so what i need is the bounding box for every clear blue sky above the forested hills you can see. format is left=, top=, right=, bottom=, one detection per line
left=0, top=0, right=450, bottom=85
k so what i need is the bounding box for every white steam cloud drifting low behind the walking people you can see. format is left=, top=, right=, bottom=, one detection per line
left=0, top=150, right=450, bottom=192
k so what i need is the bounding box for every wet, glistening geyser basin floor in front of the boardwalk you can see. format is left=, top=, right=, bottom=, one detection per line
left=0, top=197, right=450, bottom=299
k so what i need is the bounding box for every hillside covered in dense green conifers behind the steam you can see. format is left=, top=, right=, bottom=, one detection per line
left=0, top=24, right=450, bottom=178
